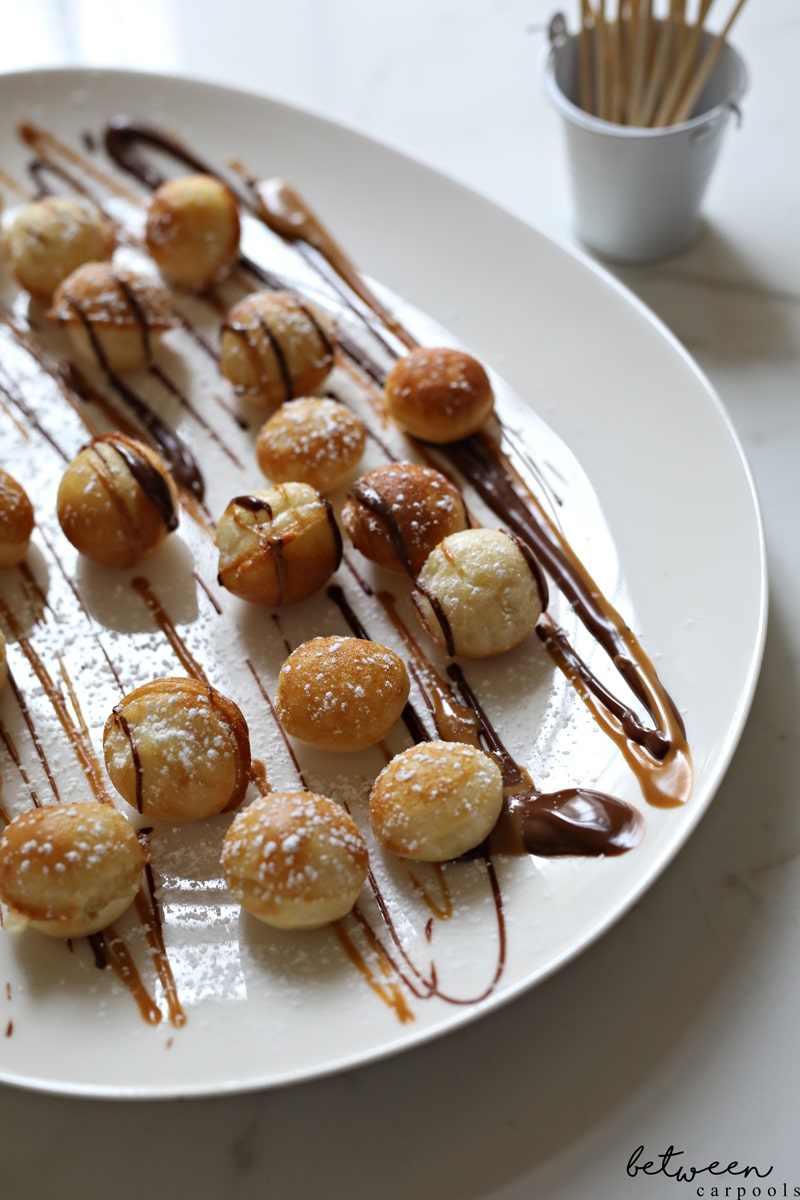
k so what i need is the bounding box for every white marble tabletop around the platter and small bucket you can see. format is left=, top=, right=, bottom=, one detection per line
left=0, top=0, right=800, bottom=1200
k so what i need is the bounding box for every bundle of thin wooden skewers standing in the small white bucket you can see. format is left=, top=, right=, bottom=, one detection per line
left=578, top=0, right=745, bottom=128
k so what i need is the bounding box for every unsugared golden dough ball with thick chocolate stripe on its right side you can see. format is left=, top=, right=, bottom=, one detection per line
left=56, top=433, right=179, bottom=566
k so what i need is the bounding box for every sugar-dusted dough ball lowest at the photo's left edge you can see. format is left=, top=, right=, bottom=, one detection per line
left=0, top=800, right=146, bottom=937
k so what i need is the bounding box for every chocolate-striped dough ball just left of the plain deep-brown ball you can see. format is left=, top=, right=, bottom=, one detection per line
left=219, top=292, right=335, bottom=406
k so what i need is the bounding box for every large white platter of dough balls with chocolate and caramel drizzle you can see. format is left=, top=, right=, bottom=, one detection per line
left=0, top=71, right=766, bottom=1097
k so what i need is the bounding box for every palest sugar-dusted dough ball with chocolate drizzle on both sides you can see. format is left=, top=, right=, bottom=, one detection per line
left=411, top=529, right=547, bottom=659
